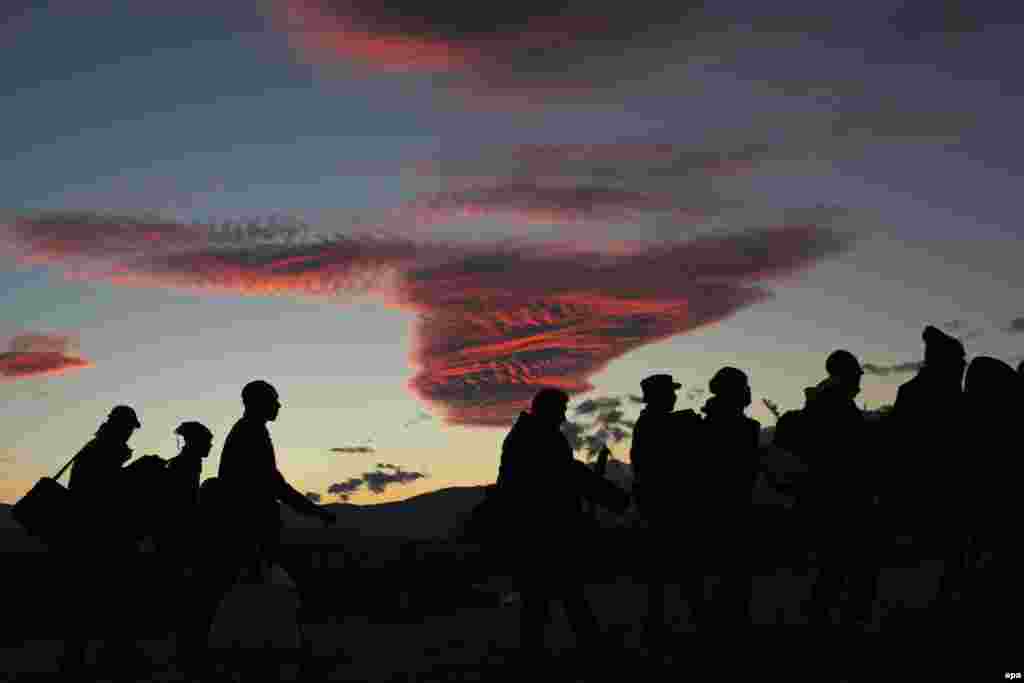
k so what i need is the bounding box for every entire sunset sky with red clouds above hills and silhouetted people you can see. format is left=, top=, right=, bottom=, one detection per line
left=0, top=0, right=1024, bottom=503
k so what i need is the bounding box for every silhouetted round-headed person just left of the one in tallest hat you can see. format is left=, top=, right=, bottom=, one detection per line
left=798, top=349, right=878, bottom=626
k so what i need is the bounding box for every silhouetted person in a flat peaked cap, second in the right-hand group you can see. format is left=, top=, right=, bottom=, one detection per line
left=630, top=373, right=703, bottom=651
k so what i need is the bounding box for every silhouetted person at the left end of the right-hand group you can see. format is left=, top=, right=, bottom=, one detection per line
left=496, top=389, right=600, bottom=658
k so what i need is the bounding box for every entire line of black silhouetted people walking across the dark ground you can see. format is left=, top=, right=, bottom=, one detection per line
left=46, top=326, right=1024, bottom=671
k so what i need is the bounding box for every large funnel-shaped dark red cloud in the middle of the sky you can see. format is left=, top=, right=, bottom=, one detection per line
left=402, top=226, right=845, bottom=426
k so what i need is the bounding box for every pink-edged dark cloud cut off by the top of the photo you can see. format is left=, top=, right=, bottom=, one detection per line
left=270, top=0, right=702, bottom=90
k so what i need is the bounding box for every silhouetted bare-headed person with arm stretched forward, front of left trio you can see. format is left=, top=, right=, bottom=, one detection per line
left=184, top=380, right=334, bottom=679
